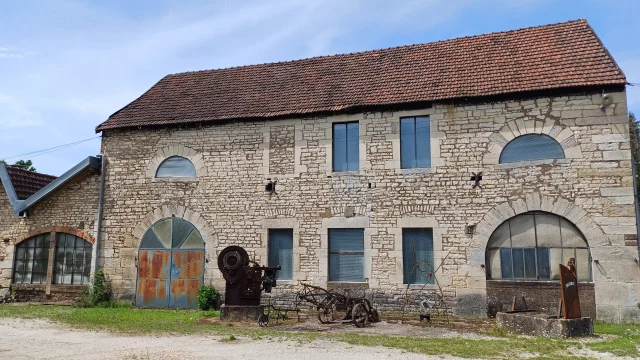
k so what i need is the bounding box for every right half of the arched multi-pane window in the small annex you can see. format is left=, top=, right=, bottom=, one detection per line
left=53, top=233, right=93, bottom=285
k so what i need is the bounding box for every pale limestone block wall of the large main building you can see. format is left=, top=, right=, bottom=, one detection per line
left=100, top=88, right=640, bottom=321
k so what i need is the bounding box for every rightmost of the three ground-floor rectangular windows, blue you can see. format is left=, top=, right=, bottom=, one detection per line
left=402, top=228, right=435, bottom=284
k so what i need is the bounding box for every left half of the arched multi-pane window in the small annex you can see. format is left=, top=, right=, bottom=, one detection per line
left=13, top=233, right=50, bottom=284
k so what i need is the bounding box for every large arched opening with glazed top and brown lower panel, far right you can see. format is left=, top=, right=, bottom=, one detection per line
left=486, top=211, right=595, bottom=316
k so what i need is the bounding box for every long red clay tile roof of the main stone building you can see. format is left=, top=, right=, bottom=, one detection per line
left=96, top=20, right=627, bottom=131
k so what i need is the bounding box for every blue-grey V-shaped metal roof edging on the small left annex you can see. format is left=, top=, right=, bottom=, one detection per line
left=0, top=156, right=101, bottom=216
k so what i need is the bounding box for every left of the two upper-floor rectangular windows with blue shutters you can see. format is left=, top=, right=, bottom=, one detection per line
left=332, top=122, right=360, bottom=172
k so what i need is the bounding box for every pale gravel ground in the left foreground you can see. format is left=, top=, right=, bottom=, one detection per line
left=0, top=319, right=456, bottom=360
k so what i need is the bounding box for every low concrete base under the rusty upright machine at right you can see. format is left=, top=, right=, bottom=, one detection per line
left=496, top=312, right=593, bottom=337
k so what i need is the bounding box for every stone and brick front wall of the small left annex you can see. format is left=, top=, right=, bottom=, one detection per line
left=0, top=173, right=100, bottom=301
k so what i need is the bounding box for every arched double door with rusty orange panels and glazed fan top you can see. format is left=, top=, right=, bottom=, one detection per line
left=136, top=217, right=204, bottom=308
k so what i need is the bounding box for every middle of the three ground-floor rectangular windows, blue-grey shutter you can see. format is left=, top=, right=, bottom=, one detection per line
left=329, top=229, right=364, bottom=282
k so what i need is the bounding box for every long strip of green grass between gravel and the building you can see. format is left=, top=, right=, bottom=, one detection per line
left=0, top=305, right=640, bottom=359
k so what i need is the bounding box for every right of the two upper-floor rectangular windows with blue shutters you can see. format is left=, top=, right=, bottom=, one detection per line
left=400, top=116, right=431, bottom=169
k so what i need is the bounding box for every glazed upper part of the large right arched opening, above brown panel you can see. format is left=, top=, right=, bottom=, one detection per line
left=486, top=212, right=592, bottom=281
